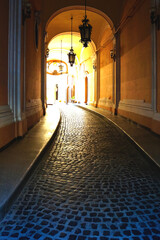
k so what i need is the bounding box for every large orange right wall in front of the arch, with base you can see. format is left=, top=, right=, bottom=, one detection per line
left=118, top=0, right=160, bottom=134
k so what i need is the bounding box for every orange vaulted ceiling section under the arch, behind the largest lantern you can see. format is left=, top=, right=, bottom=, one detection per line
left=46, top=10, right=112, bottom=47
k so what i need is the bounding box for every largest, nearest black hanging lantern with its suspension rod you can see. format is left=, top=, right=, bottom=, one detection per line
left=79, top=0, right=92, bottom=48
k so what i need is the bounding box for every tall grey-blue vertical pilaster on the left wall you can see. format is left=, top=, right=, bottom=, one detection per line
left=8, top=0, right=22, bottom=122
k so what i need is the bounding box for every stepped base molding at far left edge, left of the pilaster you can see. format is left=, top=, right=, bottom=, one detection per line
left=0, top=105, right=14, bottom=127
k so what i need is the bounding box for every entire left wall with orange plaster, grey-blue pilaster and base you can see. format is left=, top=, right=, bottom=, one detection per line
left=0, top=0, right=42, bottom=148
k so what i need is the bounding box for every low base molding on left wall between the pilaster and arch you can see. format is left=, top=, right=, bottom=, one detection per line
left=26, top=99, right=42, bottom=117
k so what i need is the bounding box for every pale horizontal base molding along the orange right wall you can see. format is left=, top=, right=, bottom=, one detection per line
left=118, top=99, right=154, bottom=118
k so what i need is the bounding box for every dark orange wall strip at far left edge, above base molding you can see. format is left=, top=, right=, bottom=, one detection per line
left=0, top=0, right=9, bottom=106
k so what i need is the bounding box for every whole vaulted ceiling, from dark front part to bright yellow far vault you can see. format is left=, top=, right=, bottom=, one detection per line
left=42, top=0, right=126, bottom=62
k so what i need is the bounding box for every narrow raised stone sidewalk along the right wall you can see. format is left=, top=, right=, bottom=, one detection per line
left=78, top=105, right=160, bottom=167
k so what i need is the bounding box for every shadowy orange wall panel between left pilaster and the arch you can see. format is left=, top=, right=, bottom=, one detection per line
left=26, top=0, right=41, bottom=102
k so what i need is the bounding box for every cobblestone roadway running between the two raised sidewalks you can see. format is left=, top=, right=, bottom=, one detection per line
left=0, top=106, right=160, bottom=240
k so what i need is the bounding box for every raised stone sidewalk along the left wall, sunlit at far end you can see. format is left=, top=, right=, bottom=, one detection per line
left=0, top=107, right=60, bottom=219
